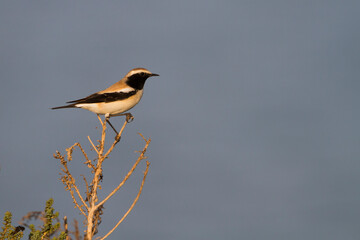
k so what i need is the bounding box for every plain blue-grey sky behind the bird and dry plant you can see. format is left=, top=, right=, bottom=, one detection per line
left=0, top=0, right=360, bottom=240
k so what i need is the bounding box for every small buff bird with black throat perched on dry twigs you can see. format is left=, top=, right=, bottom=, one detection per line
left=51, top=68, right=160, bottom=134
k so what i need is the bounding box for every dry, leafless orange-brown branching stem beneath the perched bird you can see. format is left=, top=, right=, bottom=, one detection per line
left=54, top=116, right=151, bottom=240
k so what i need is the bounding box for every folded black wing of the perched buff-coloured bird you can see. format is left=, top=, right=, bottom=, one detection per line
left=67, top=90, right=137, bottom=104
